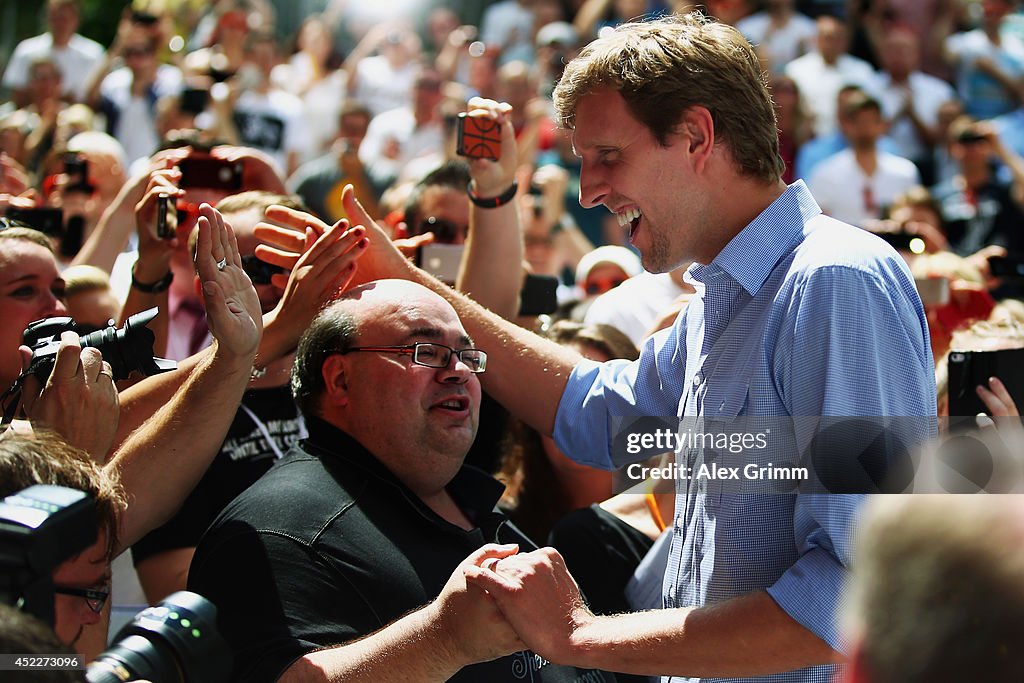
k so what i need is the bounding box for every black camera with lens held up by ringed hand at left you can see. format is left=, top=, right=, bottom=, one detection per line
left=24, top=308, right=177, bottom=382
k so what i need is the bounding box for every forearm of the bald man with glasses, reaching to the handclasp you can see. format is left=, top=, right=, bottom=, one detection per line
left=278, top=605, right=471, bottom=683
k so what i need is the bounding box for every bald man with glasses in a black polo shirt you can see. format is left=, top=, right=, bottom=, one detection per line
left=188, top=281, right=614, bottom=682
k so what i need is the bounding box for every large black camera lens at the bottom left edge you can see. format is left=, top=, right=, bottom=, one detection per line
left=85, top=591, right=231, bottom=683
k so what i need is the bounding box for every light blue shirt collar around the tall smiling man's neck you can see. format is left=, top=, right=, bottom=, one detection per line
left=686, top=180, right=821, bottom=296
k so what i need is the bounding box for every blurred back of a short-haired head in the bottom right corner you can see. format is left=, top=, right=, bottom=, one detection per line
left=846, top=495, right=1024, bottom=683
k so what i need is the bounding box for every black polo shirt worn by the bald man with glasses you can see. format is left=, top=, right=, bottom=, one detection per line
left=188, top=419, right=614, bottom=683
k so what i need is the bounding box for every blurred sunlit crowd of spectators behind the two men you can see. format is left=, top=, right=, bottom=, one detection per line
left=0, top=0, right=1024, bottom=679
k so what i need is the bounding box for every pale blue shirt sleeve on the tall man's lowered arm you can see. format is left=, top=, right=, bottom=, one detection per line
left=768, top=259, right=935, bottom=650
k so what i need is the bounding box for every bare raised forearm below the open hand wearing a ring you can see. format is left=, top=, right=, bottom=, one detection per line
left=108, top=342, right=252, bottom=548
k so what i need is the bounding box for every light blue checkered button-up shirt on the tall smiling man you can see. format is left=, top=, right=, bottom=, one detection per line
left=555, top=181, right=935, bottom=683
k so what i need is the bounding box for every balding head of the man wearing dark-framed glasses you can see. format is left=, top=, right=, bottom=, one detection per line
left=292, top=280, right=486, bottom=493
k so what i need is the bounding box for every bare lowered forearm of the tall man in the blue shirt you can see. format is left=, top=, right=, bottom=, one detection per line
left=569, top=591, right=843, bottom=678
